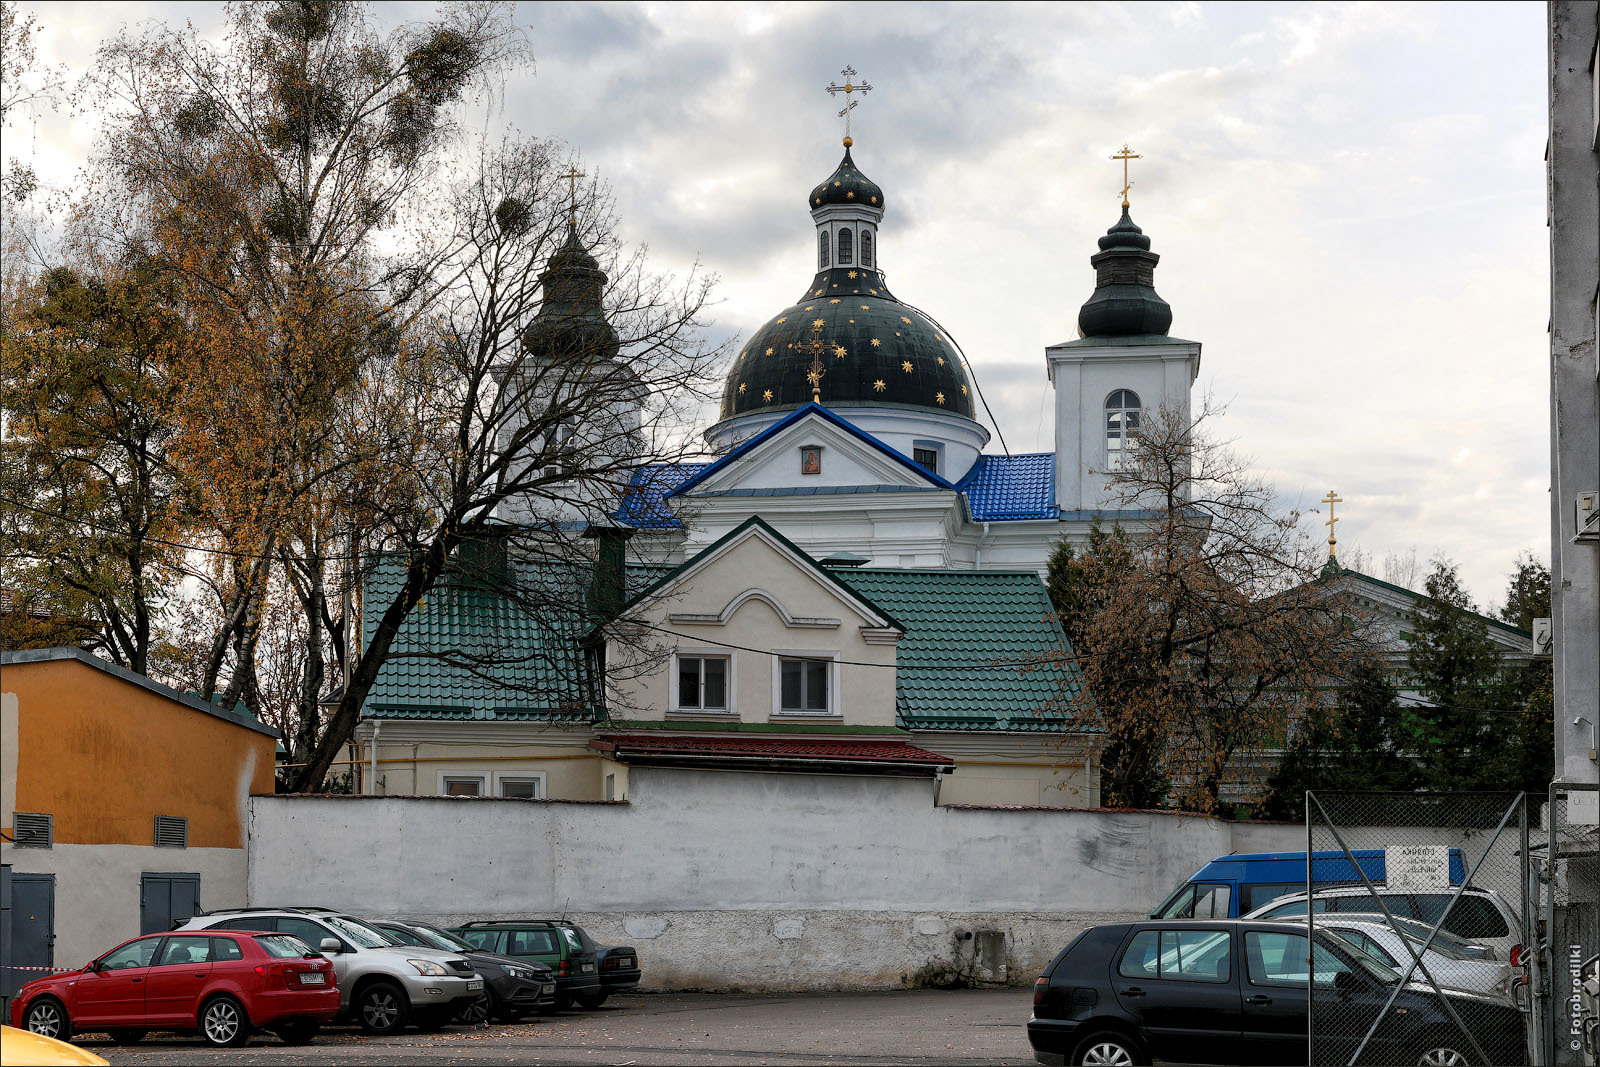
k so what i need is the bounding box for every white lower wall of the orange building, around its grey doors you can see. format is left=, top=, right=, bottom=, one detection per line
left=0, top=845, right=248, bottom=968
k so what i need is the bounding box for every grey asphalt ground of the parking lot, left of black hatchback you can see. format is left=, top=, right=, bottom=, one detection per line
left=78, top=989, right=1034, bottom=1065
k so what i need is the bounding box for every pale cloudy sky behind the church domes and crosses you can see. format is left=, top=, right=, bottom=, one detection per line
left=6, top=2, right=1549, bottom=605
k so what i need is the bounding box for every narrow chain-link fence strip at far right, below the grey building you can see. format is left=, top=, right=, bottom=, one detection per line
left=1536, top=784, right=1600, bottom=1067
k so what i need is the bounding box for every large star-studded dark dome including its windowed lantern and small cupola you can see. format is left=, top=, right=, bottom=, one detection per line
left=722, top=144, right=976, bottom=419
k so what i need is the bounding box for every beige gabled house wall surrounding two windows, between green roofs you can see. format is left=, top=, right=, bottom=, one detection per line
left=606, top=531, right=894, bottom=726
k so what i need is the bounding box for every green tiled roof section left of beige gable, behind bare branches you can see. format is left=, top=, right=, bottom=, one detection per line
left=362, top=555, right=592, bottom=720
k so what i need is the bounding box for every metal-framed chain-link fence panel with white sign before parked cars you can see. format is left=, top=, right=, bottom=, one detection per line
left=1305, top=792, right=1542, bottom=1067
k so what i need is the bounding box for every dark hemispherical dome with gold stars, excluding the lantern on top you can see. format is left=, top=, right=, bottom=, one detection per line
left=722, top=267, right=976, bottom=419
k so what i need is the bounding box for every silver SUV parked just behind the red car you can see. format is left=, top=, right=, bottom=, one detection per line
left=178, top=907, right=483, bottom=1033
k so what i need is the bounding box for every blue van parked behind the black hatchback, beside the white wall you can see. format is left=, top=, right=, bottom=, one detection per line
left=1150, top=848, right=1466, bottom=918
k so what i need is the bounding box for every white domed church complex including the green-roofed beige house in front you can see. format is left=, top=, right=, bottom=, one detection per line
left=347, top=103, right=1200, bottom=806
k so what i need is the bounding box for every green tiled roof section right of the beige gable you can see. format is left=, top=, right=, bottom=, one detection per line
left=834, top=568, right=1082, bottom=731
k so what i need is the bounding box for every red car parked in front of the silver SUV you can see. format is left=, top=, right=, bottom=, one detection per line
left=11, top=929, right=339, bottom=1048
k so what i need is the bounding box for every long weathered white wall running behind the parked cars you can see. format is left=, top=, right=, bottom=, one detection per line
left=250, top=768, right=1304, bottom=990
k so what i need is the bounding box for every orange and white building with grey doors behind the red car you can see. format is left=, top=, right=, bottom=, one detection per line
left=0, top=648, right=278, bottom=993
